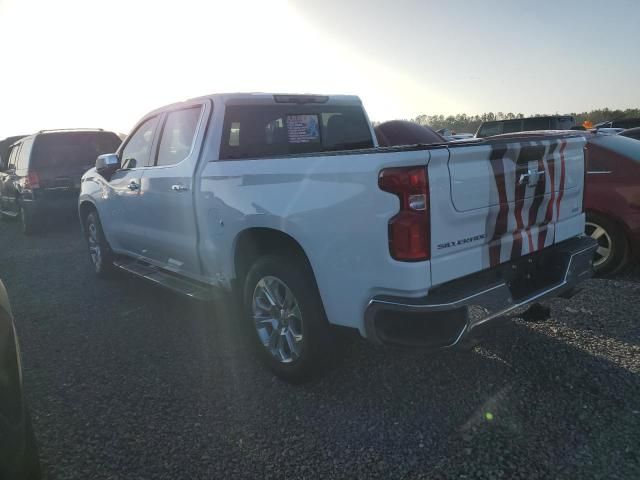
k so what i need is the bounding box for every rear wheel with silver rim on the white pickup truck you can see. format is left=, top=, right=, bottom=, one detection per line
left=243, top=255, right=336, bottom=383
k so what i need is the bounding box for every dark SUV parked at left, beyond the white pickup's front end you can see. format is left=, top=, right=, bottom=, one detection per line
left=0, top=129, right=121, bottom=234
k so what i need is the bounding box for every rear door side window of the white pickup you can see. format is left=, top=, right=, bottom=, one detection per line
left=156, top=107, right=202, bottom=165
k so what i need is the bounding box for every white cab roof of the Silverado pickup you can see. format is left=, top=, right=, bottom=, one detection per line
left=145, top=92, right=362, bottom=117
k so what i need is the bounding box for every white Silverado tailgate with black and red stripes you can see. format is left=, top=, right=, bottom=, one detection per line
left=429, top=135, right=585, bottom=285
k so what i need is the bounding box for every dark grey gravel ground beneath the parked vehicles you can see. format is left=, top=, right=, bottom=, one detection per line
left=0, top=218, right=640, bottom=480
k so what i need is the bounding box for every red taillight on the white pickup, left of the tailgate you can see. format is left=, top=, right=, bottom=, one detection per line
left=378, top=166, right=431, bottom=262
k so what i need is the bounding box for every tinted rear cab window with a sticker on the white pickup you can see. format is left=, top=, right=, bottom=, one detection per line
left=220, top=104, right=373, bottom=160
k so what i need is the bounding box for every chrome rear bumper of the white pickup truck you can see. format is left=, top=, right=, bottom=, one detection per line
left=365, top=236, right=597, bottom=349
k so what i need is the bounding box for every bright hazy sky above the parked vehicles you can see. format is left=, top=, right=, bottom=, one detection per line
left=0, top=0, right=640, bottom=138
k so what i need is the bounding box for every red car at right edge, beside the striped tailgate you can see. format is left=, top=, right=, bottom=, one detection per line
left=585, top=134, right=640, bottom=274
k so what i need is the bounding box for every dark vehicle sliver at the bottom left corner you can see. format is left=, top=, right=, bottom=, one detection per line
left=0, top=281, right=41, bottom=480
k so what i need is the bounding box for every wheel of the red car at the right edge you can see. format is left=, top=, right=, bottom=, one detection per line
left=585, top=213, right=629, bottom=275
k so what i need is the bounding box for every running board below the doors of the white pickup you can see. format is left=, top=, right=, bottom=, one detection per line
left=113, top=259, right=213, bottom=301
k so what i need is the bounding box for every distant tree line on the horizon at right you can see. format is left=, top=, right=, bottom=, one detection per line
left=412, top=108, right=640, bottom=133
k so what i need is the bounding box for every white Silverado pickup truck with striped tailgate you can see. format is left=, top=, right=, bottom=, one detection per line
left=79, top=94, right=595, bottom=381
